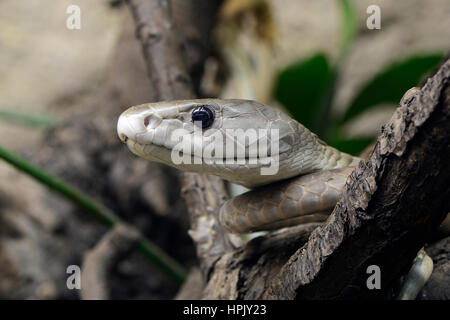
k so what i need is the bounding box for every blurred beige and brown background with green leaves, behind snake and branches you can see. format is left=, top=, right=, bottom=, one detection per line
left=0, top=0, right=450, bottom=299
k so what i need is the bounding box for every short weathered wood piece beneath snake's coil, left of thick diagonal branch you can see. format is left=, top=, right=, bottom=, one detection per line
left=202, top=223, right=319, bottom=300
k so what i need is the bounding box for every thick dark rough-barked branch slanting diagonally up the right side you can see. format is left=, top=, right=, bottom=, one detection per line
left=264, top=60, right=450, bottom=299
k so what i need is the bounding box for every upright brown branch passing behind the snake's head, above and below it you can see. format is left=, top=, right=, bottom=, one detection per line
left=127, top=0, right=234, bottom=277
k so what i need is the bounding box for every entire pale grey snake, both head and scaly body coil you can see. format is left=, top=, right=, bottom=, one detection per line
left=117, top=99, right=361, bottom=233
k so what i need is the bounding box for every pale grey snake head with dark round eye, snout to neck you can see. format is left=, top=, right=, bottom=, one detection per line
left=117, top=99, right=336, bottom=187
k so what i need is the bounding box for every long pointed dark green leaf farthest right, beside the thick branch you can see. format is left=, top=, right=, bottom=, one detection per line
left=339, top=54, right=443, bottom=124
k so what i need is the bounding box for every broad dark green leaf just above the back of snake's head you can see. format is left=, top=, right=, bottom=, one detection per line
left=275, top=54, right=333, bottom=131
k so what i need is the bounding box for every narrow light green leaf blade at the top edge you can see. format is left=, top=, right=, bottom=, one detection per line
left=338, top=0, right=357, bottom=64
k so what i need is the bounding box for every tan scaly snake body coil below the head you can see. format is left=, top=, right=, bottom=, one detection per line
left=219, top=167, right=353, bottom=233
